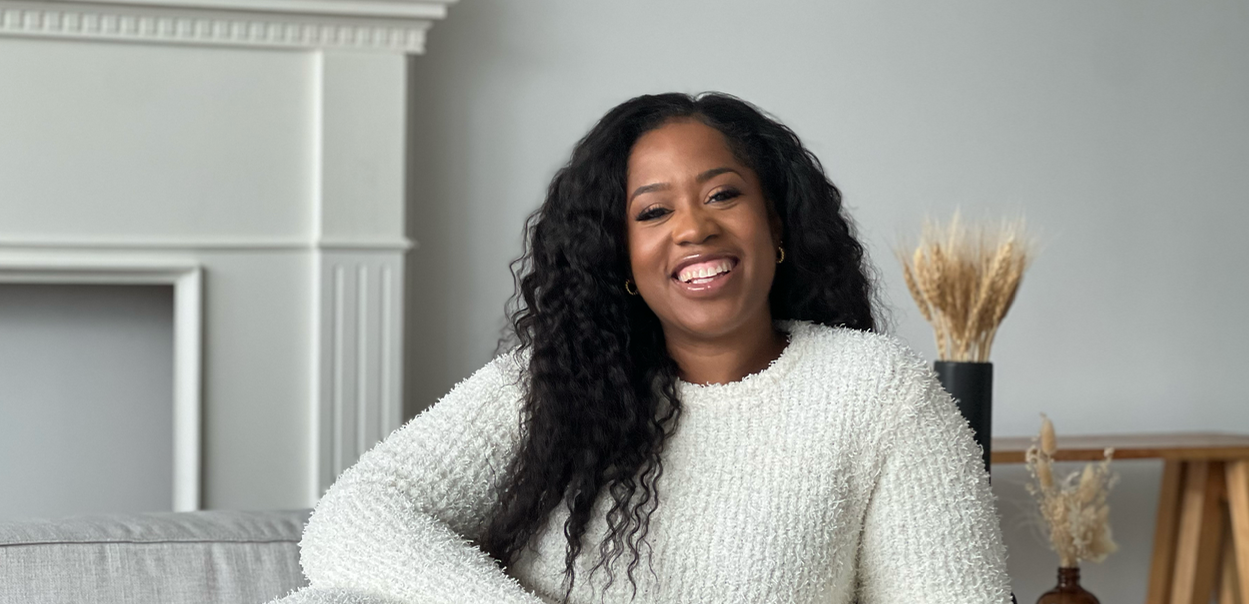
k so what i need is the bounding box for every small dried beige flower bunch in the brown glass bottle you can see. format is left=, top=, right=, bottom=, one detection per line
left=1027, top=414, right=1119, bottom=567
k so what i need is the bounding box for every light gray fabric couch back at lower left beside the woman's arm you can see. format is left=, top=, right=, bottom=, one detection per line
left=0, top=510, right=309, bottom=604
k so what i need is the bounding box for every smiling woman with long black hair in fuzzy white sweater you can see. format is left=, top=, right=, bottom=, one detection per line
left=273, top=94, right=1010, bottom=604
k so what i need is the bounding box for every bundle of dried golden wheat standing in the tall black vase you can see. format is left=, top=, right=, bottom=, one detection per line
left=897, top=211, right=1034, bottom=363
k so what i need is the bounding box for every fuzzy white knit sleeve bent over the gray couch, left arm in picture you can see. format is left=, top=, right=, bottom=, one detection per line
left=300, top=357, right=554, bottom=604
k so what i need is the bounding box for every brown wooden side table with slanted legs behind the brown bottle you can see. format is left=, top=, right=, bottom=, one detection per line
left=993, top=433, right=1249, bottom=604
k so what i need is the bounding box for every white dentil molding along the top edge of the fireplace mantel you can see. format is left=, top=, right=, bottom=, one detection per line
left=0, top=0, right=456, bottom=54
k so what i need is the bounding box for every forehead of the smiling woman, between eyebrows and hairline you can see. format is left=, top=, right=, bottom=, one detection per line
left=628, top=120, right=741, bottom=185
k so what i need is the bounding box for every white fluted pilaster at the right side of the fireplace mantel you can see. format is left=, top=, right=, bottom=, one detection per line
left=310, top=52, right=407, bottom=500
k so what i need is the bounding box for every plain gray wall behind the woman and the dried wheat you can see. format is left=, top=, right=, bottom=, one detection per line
left=406, top=0, right=1249, bottom=602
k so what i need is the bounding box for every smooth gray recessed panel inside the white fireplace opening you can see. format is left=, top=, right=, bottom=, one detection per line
left=0, top=283, right=174, bottom=519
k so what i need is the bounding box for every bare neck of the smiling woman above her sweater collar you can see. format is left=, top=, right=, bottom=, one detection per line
left=663, top=316, right=787, bottom=384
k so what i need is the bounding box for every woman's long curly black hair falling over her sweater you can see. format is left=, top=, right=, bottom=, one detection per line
left=481, top=92, right=877, bottom=600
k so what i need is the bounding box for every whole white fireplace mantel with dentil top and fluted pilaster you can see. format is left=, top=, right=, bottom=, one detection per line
left=0, top=0, right=453, bottom=509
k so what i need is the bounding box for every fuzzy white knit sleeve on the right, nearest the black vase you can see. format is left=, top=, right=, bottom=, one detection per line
left=858, top=351, right=1010, bottom=604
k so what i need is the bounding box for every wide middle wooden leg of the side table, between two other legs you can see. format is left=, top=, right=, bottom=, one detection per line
left=1170, top=462, right=1224, bottom=604
